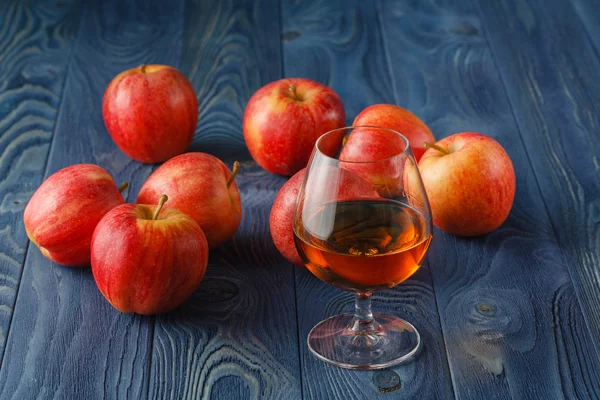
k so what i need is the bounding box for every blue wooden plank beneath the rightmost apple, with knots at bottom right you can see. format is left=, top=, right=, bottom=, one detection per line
left=379, top=0, right=600, bottom=399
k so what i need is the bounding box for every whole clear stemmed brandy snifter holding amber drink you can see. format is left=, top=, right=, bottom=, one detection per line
left=293, top=126, right=432, bottom=369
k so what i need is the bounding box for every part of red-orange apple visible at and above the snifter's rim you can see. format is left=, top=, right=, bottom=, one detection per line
left=340, top=104, right=435, bottom=162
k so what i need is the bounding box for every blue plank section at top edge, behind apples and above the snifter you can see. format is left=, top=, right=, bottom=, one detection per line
left=282, top=0, right=394, bottom=124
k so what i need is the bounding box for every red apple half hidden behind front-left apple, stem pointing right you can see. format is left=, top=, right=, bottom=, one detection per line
left=136, top=153, right=242, bottom=248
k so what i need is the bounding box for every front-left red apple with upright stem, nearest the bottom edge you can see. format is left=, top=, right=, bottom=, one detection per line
left=91, top=196, right=208, bottom=315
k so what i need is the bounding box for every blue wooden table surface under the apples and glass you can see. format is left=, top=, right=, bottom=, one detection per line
left=0, top=0, right=600, bottom=400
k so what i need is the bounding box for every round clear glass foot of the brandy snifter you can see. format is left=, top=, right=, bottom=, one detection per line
left=308, top=313, right=421, bottom=369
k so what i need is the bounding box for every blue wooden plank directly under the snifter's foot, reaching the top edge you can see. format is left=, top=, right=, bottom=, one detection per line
left=283, top=0, right=453, bottom=399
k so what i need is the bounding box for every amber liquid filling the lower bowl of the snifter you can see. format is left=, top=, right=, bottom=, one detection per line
left=294, top=200, right=431, bottom=292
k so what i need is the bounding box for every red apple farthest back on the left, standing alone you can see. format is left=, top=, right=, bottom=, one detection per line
left=102, top=65, right=198, bottom=163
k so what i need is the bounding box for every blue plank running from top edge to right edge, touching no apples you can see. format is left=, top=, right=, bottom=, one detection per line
left=478, top=0, right=600, bottom=356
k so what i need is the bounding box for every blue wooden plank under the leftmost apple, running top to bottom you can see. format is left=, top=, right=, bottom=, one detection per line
left=0, top=0, right=182, bottom=399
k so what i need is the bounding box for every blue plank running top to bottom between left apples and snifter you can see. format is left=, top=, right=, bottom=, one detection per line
left=150, top=0, right=300, bottom=399
